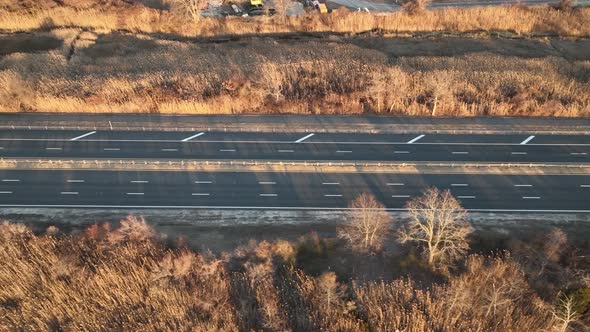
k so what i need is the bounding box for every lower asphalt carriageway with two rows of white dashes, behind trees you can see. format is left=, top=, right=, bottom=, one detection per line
left=0, top=170, right=590, bottom=212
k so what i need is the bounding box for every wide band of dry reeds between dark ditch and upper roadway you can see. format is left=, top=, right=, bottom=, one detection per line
left=0, top=29, right=590, bottom=117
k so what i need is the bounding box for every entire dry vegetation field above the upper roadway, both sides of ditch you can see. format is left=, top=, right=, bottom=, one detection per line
left=0, top=0, right=590, bottom=117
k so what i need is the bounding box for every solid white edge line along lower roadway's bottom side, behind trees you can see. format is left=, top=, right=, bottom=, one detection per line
left=0, top=204, right=590, bottom=213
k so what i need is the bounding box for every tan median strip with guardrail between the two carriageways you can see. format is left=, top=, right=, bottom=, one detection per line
left=0, top=159, right=590, bottom=175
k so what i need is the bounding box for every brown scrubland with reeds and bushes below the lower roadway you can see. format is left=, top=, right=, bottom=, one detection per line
left=0, top=217, right=590, bottom=332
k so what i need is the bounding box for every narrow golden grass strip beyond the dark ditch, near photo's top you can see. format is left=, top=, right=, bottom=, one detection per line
left=0, top=5, right=590, bottom=36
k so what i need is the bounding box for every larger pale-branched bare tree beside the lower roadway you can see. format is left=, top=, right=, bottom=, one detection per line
left=398, top=188, right=472, bottom=267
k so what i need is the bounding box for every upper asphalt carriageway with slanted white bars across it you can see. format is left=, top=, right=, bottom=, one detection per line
left=0, top=130, right=590, bottom=163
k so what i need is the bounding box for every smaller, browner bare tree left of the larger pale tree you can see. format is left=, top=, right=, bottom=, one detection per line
left=338, top=193, right=392, bottom=252
